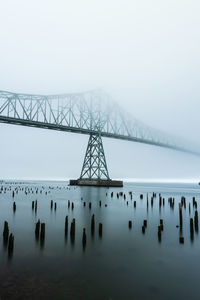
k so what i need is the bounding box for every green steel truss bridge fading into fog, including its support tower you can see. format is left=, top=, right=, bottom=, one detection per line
left=0, top=90, right=198, bottom=186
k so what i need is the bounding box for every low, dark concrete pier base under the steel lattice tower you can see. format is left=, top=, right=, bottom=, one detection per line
left=69, top=179, right=123, bottom=187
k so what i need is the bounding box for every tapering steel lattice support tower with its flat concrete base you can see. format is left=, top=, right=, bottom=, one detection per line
left=70, top=132, right=123, bottom=187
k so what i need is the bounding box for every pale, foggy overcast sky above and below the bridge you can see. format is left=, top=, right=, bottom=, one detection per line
left=0, top=0, right=200, bottom=179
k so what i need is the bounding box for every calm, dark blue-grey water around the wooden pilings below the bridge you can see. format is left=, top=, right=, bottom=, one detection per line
left=0, top=182, right=200, bottom=300
